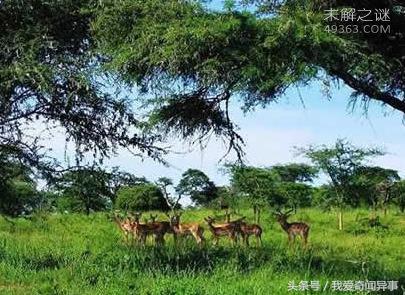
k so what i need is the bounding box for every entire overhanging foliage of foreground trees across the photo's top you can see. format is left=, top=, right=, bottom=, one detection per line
left=0, top=0, right=405, bottom=167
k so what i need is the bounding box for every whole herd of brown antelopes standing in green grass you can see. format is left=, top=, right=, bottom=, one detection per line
left=114, top=210, right=309, bottom=246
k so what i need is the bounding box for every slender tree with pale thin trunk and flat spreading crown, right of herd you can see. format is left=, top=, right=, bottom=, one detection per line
left=299, top=139, right=384, bottom=230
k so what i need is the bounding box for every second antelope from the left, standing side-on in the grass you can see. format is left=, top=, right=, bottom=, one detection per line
left=132, top=213, right=170, bottom=245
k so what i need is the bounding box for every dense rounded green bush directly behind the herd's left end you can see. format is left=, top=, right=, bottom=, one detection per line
left=115, top=183, right=169, bottom=211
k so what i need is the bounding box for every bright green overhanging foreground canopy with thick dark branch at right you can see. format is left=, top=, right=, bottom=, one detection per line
left=93, top=0, right=405, bottom=155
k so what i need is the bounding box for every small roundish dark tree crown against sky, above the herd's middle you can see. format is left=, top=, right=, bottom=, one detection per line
left=176, top=169, right=218, bottom=206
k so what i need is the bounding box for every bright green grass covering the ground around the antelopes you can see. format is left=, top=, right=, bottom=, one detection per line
left=0, top=209, right=405, bottom=295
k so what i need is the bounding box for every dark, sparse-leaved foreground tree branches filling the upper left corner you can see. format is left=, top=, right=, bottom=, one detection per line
left=0, top=0, right=162, bottom=176
